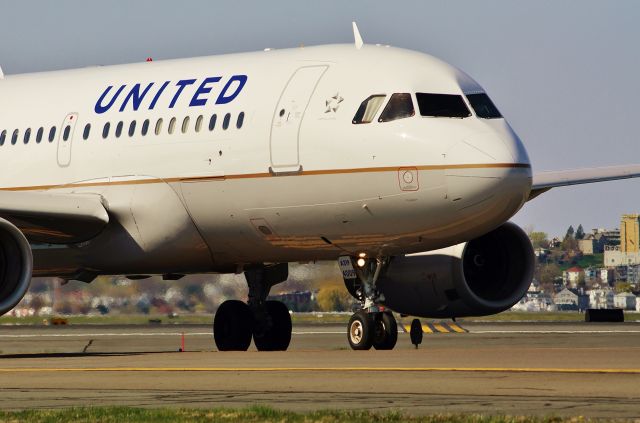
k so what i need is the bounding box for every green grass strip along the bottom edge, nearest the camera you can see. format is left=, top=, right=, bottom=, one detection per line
left=0, top=406, right=587, bottom=423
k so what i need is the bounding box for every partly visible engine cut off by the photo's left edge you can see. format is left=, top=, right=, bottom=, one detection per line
left=0, top=218, right=33, bottom=316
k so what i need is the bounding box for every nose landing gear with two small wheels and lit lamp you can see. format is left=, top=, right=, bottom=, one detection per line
left=340, top=257, right=398, bottom=350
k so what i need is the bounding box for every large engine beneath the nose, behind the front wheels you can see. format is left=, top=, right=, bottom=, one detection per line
left=377, top=222, right=535, bottom=318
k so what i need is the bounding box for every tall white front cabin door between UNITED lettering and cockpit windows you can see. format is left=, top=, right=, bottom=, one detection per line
left=269, top=66, right=328, bottom=173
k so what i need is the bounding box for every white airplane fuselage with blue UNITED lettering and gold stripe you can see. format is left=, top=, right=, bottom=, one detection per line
left=0, top=45, right=531, bottom=277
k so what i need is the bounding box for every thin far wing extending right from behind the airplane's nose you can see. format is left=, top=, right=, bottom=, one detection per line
left=528, top=165, right=640, bottom=201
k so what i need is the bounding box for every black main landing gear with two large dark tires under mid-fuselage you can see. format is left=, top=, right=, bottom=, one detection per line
left=213, top=263, right=291, bottom=351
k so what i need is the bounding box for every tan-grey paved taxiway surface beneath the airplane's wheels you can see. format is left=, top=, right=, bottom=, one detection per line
left=0, top=323, right=640, bottom=418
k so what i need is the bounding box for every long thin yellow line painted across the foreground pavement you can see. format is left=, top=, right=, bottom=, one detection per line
left=0, top=367, right=640, bottom=375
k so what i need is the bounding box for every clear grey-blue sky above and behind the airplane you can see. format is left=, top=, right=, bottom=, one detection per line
left=0, top=0, right=640, bottom=235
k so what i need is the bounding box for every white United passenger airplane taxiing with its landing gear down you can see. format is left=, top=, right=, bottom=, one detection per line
left=0, top=23, right=640, bottom=351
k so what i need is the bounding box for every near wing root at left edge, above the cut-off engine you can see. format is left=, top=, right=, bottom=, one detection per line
left=0, top=191, right=109, bottom=244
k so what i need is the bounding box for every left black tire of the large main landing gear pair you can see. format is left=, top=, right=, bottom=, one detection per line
left=213, top=300, right=253, bottom=351
